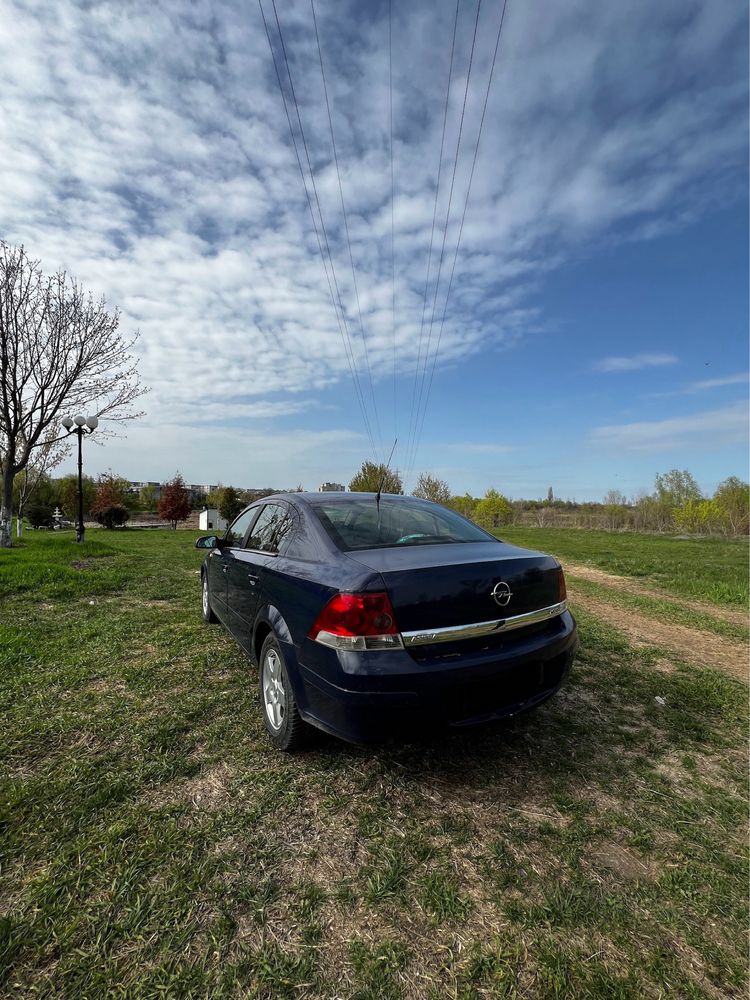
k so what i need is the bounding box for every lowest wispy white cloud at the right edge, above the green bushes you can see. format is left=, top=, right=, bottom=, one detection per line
left=589, top=402, right=748, bottom=452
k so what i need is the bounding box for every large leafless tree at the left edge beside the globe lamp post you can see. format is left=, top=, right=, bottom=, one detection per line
left=0, top=242, right=146, bottom=548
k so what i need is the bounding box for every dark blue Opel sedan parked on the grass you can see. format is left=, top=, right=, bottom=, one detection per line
left=196, top=493, right=577, bottom=750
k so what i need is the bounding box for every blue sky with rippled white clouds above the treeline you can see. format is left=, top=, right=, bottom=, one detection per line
left=0, top=0, right=748, bottom=500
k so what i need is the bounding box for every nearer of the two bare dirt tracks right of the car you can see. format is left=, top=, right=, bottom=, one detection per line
left=567, top=588, right=748, bottom=681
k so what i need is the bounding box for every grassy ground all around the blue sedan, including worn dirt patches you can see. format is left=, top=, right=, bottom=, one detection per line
left=0, top=529, right=748, bottom=1000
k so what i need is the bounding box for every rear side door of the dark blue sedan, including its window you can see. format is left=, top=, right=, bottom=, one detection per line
left=227, top=502, right=292, bottom=650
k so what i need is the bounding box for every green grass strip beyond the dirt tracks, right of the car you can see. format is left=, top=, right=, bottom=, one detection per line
left=499, top=525, right=748, bottom=608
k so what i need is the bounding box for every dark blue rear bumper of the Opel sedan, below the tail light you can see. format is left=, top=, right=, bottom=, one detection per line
left=285, top=611, right=578, bottom=743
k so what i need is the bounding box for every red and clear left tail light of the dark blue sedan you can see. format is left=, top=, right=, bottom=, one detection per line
left=308, top=593, right=403, bottom=650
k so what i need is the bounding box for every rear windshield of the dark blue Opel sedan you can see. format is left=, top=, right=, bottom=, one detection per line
left=314, top=497, right=496, bottom=552
